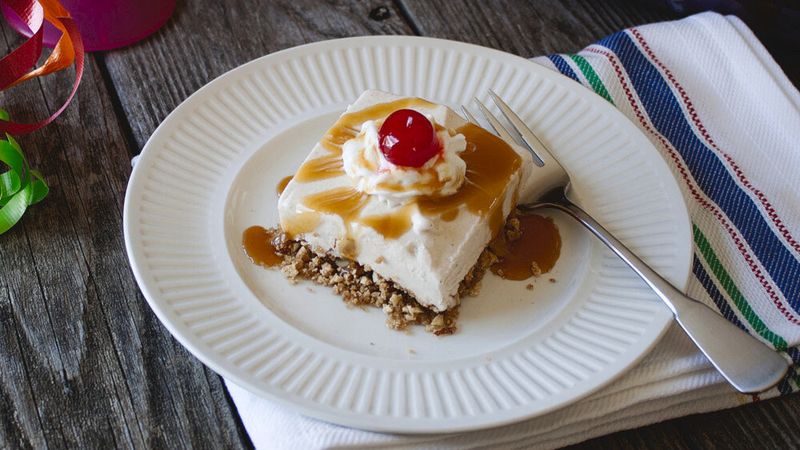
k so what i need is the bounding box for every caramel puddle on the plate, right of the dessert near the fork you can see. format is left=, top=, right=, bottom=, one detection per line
left=490, top=214, right=561, bottom=280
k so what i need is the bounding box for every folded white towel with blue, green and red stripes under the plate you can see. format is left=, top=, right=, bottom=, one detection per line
left=228, top=13, right=800, bottom=449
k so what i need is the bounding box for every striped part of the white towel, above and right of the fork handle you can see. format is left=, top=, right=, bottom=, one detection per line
left=535, top=13, right=800, bottom=358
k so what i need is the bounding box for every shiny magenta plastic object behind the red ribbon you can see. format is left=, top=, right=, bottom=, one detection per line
left=2, top=0, right=176, bottom=52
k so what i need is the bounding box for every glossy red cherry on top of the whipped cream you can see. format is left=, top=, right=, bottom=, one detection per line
left=378, top=109, right=439, bottom=167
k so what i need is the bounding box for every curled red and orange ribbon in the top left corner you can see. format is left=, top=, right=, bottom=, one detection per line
left=0, top=0, right=84, bottom=135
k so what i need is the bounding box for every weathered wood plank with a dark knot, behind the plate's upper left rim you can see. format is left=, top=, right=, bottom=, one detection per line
left=106, top=0, right=412, bottom=148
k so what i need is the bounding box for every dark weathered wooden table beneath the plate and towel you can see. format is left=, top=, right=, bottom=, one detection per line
left=0, top=0, right=800, bottom=448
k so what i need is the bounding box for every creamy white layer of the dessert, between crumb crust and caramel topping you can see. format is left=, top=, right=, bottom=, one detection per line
left=278, top=90, right=533, bottom=311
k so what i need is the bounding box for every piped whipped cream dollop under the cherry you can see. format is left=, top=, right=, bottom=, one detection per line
left=342, top=120, right=467, bottom=203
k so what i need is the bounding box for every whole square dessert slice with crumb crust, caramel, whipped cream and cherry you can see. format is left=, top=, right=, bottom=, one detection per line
left=274, top=90, right=532, bottom=333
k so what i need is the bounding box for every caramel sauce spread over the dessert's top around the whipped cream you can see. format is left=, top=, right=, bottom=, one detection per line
left=281, top=98, right=522, bottom=250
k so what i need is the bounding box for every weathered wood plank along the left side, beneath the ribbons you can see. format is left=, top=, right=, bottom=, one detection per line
left=0, top=23, right=248, bottom=448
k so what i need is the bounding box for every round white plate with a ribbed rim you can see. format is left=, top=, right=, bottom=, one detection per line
left=124, top=37, right=691, bottom=433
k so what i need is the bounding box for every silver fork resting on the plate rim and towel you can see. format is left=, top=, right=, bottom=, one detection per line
left=462, top=90, right=789, bottom=394
